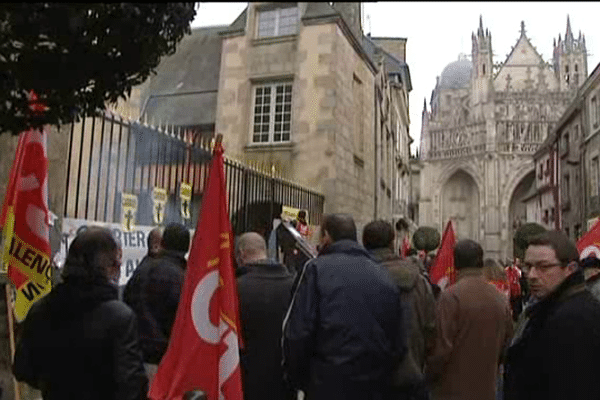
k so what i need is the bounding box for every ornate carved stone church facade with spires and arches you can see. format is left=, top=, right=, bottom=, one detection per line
left=419, top=17, right=587, bottom=259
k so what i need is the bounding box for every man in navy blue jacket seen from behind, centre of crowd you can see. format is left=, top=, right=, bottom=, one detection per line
left=283, top=214, right=406, bottom=400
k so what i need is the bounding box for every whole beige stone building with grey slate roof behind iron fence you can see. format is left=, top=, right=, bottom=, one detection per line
left=137, top=2, right=412, bottom=229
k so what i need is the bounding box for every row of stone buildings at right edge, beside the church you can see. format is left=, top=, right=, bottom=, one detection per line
left=524, top=65, right=600, bottom=240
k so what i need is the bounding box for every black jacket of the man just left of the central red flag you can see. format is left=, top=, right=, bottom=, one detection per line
left=123, top=250, right=186, bottom=364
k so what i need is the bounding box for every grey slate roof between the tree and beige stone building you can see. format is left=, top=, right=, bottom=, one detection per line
left=141, top=26, right=224, bottom=126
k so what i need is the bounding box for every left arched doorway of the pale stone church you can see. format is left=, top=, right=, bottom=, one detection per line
left=441, top=170, right=479, bottom=241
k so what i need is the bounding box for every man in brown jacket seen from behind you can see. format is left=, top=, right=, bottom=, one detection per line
left=427, top=240, right=513, bottom=400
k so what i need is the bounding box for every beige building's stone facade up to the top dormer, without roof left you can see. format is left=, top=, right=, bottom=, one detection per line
left=216, top=3, right=410, bottom=229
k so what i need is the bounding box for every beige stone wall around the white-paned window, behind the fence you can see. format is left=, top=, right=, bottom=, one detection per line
left=216, top=4, right=374, bottom=227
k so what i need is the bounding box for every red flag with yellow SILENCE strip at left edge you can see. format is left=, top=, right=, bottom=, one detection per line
left=0, top=128, right=52, bottom=321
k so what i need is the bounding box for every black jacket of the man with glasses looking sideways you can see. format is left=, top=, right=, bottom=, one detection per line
left=504, top=271, right=600, bottom=400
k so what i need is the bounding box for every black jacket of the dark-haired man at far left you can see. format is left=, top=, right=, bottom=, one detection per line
left=13, top=281, right=148, bottom=400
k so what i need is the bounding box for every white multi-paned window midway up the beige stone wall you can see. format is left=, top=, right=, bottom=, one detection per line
left=252, top=82, right=292, bottom=143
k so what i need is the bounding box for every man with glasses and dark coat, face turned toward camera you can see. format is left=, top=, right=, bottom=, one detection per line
left=504, top=231, right=600, bottom=400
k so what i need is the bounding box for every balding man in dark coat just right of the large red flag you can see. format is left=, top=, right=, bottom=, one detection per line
left=236, top=232, right=295, bottom=400
